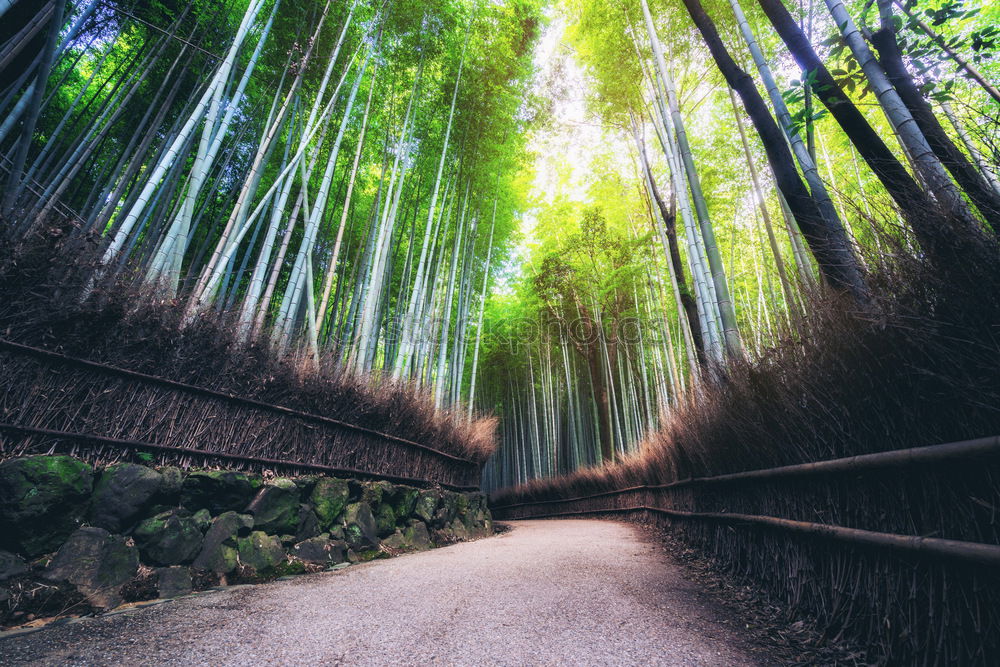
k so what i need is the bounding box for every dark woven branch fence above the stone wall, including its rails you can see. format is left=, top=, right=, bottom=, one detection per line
left=0, top=339, right=481, bottom=490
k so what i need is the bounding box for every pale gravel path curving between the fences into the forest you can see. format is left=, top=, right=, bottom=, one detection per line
left=0, top=520, right=757, bottom=666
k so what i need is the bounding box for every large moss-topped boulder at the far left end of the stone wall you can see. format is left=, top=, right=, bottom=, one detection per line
left=0, top=456, right=94, bottom=558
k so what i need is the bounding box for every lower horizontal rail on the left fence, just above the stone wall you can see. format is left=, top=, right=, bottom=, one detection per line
left=0, top=422, right=479, bottom=491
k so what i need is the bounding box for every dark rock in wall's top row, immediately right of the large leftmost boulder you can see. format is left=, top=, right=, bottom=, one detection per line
left=90, top=463, right=163, bottom=533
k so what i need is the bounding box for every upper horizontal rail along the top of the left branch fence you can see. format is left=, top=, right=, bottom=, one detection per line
left=0, top=338, right=479, bottom=467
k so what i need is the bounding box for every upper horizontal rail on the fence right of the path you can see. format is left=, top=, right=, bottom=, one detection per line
left=493, top=436, right=1000, bottom=511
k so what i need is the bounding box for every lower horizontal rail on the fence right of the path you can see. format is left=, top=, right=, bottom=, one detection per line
left=508, top=505, right=1000, bottom=567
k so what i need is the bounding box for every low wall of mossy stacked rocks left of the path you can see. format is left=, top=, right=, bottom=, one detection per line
left=0, top=456, right=493, bottom=625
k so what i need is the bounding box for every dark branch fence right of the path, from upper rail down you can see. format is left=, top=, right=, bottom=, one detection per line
left=491, top=437, right=1000, bottom=665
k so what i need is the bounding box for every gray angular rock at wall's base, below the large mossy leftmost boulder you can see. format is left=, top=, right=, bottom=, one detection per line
left=44, top=526, right=139, bottom=609
